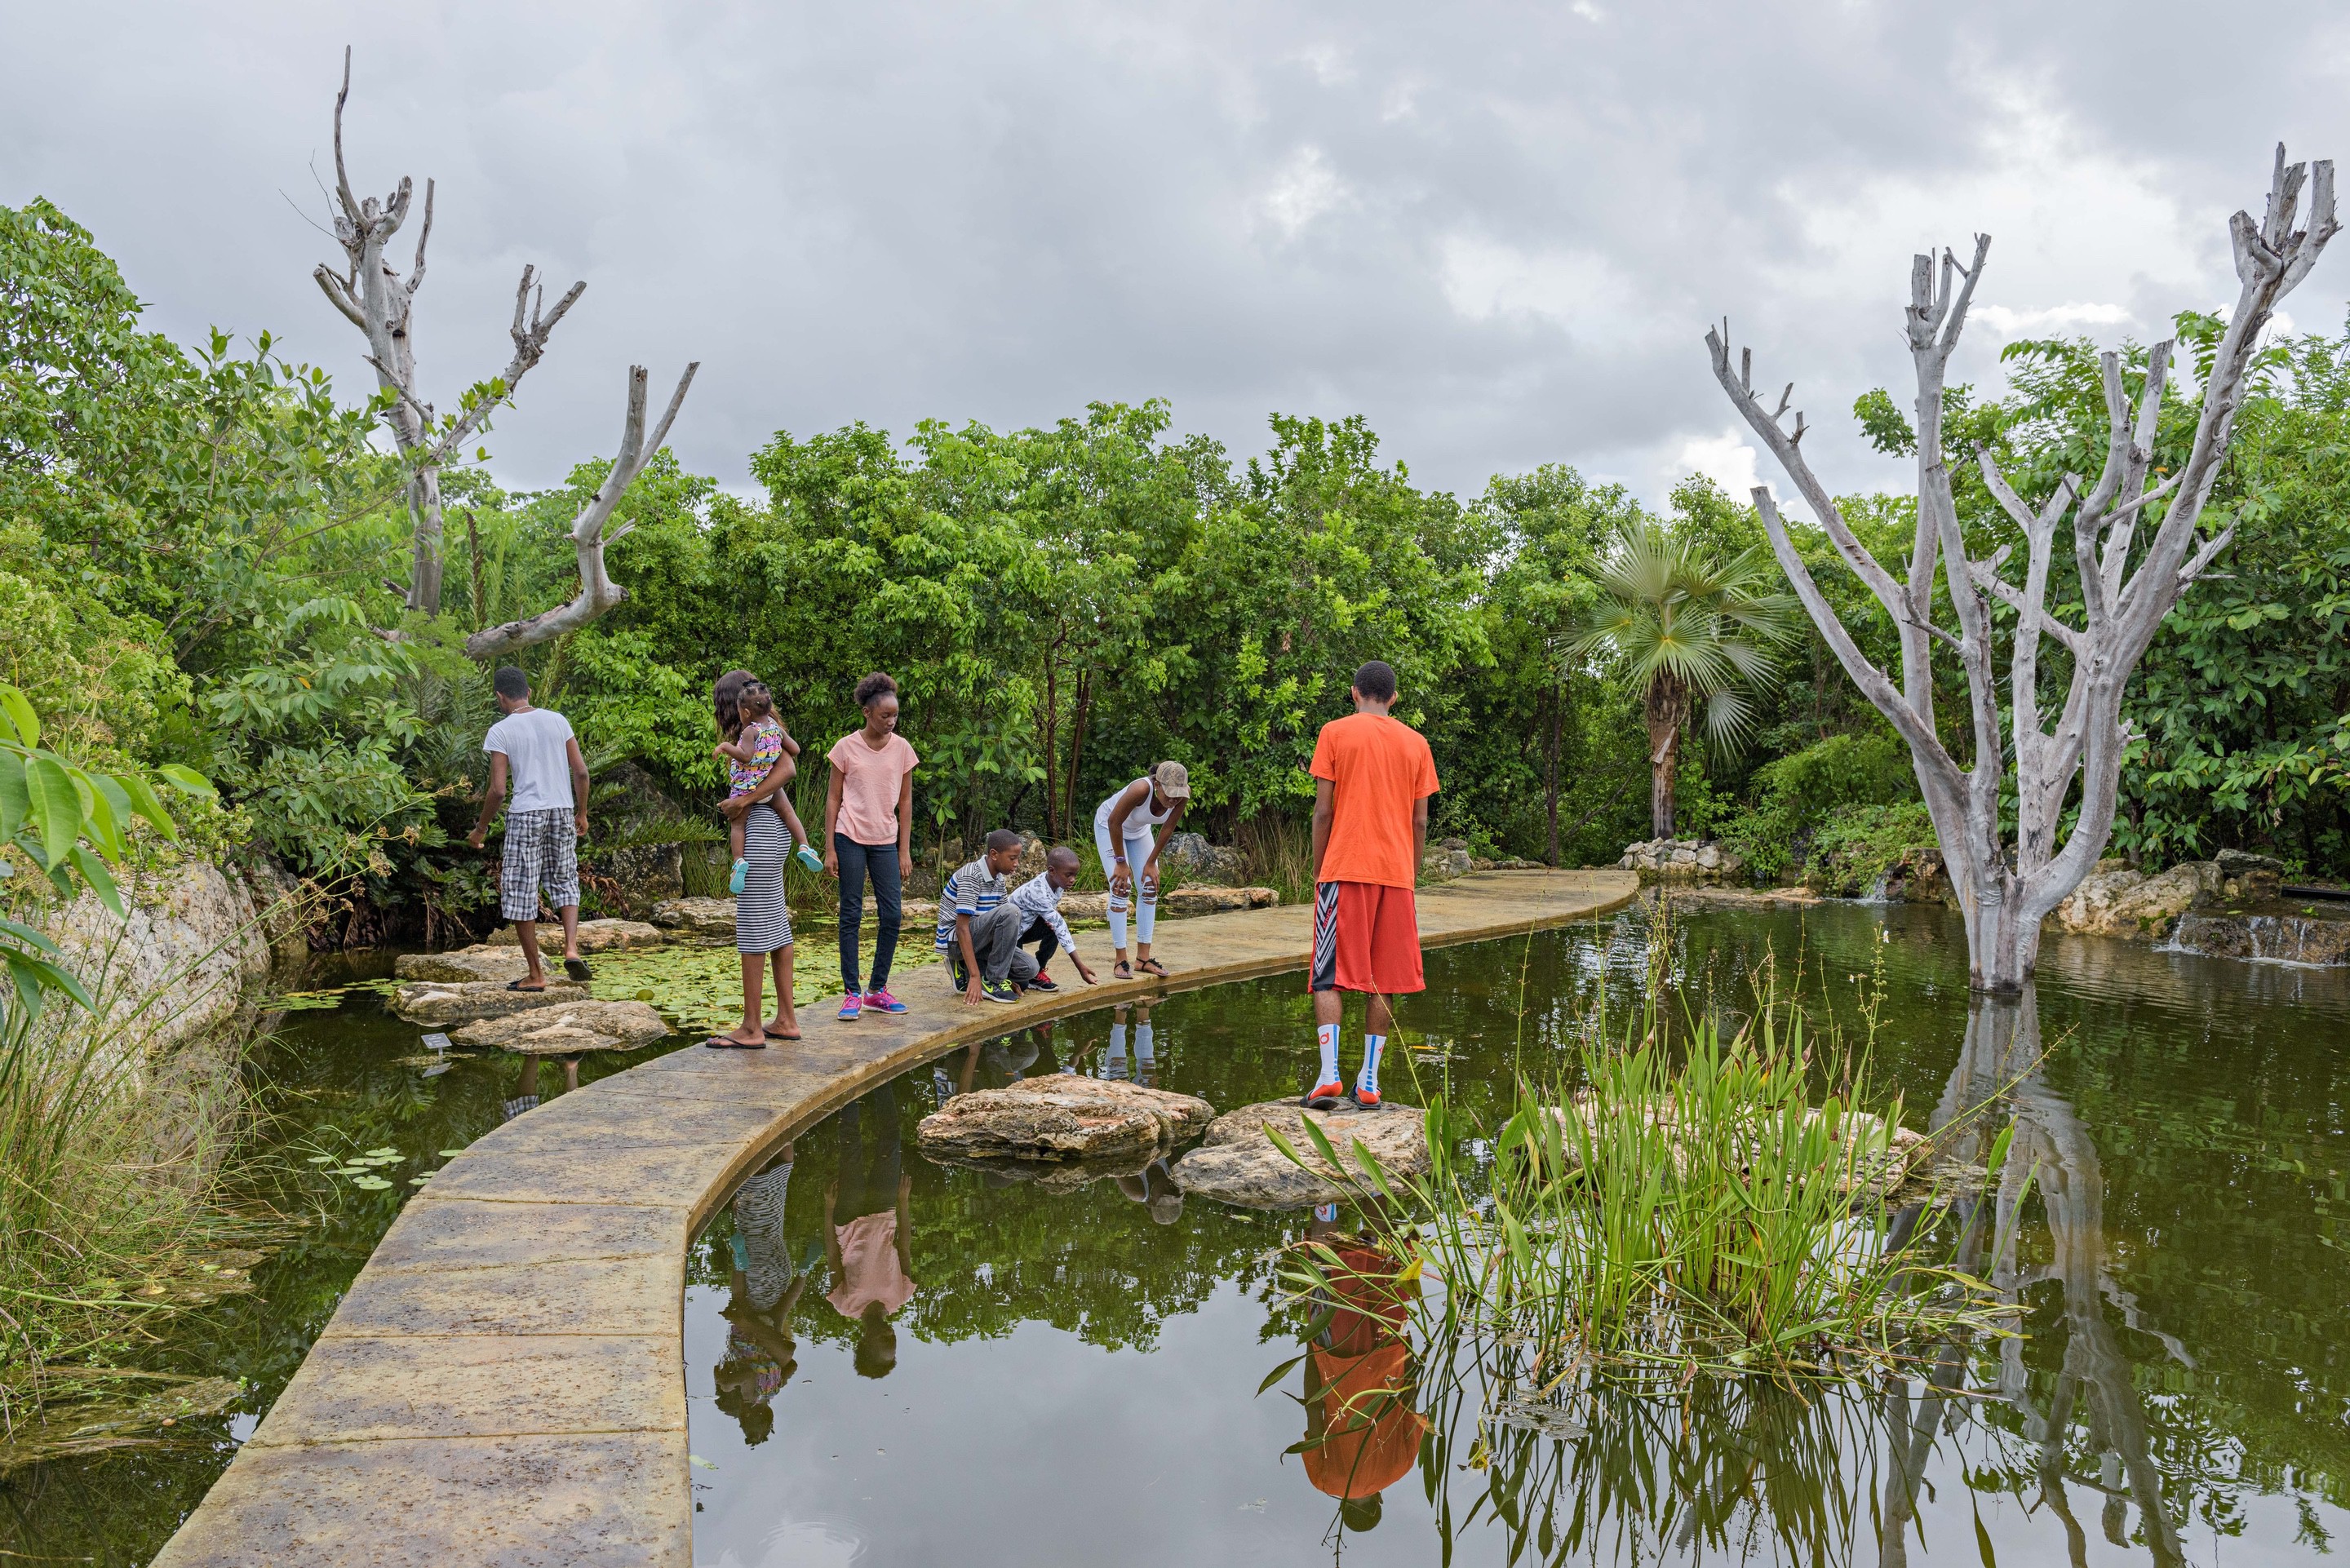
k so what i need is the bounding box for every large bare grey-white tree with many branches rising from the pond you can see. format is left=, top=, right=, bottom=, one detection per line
left=1706, top=146, right=2339, bottom=992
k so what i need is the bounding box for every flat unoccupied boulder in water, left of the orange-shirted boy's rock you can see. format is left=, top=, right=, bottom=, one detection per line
left=919, top=1072, right=1215, bottom=1163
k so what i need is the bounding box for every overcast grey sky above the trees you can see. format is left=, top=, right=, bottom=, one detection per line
left=0, top=0, right=2350, bottom=510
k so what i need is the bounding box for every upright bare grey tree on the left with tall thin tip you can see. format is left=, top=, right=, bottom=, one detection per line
left=310, top=47, right=588, bottom=616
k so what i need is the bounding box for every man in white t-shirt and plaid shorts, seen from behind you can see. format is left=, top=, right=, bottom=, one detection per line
left=465, top=665, right=588, bottom=992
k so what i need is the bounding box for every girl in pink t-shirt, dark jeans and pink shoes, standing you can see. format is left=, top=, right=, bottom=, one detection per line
left=825, top=675, right=921, bottom=1018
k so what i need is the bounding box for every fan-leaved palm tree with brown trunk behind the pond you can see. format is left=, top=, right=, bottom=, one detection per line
left=1570, top=522, right=1795, bottom=839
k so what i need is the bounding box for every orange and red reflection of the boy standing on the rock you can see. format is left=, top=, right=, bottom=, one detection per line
left=1304, top=1203, right=1429, bottom=1533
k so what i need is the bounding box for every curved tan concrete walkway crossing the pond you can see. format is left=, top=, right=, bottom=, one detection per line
left=155, top=870, right=1635, bottom=1568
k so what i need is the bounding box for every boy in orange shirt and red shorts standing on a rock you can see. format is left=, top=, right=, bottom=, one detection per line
left=1304, top=658, right=1436, bottom=1110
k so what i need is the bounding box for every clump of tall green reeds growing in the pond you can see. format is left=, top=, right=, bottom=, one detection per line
left=1292, top=968, right=2014, bottom=1399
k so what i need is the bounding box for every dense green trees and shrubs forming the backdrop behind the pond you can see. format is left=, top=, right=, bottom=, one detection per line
left=0, top=202, right=2350, bottom=936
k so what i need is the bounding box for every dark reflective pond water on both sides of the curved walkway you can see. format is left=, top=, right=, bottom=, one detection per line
left=0, top=905, right=2350, bottom=1568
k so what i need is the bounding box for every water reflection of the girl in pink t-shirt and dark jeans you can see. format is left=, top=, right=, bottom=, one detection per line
left=825, top=1083, right=914, bottom=1378
